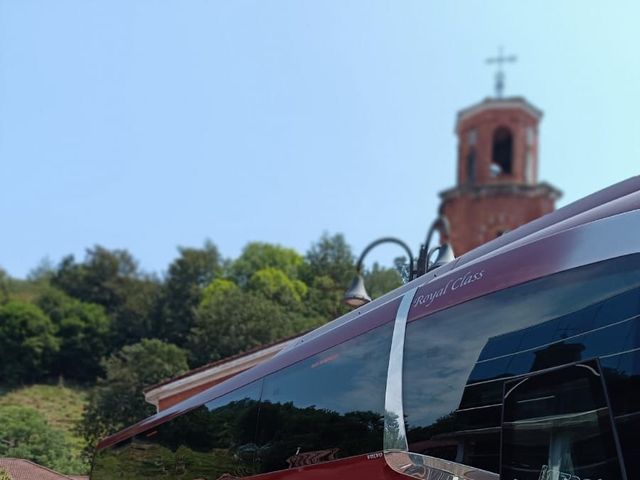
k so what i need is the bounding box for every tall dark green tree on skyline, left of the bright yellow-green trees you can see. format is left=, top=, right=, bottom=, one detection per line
left=157, top=241, right=222, bottom=345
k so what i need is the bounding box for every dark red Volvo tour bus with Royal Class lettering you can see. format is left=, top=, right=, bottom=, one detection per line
left=91, top=177, right=640, bottom=480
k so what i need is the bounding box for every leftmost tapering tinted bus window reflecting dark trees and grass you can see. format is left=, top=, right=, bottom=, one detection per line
left=91, top=382, right=261, bottom=480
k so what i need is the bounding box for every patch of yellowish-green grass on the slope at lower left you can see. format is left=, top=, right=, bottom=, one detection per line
left=0, top=385, right=88, bottom=466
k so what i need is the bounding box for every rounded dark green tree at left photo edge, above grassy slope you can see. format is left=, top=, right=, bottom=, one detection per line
left=0, top=301, right=60, bottom=382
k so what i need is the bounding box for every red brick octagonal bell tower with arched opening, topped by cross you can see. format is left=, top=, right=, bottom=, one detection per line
left=440, top=52, right=562, bottom=256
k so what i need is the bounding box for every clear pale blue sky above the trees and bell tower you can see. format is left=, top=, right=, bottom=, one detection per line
left=0, top=0, right=640, bottom=277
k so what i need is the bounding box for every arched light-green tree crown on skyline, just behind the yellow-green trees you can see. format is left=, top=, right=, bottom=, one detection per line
left=230, top=242, right=304, bottom=286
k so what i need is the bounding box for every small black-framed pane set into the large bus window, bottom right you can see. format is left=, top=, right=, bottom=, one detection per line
left=501, top=361, right=622, bottom=480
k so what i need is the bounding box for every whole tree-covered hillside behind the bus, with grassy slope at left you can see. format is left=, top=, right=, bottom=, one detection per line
left=0, top=234, right=403, bottom=473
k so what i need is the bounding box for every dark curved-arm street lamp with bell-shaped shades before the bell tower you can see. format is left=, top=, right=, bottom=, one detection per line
left=343, top=215, right=455, bottom=308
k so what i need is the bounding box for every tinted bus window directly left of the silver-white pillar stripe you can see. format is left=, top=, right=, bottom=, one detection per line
left=257, top=323, right=393, bottom=472
